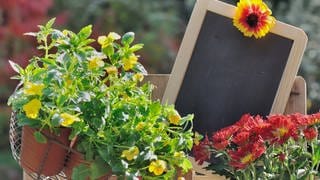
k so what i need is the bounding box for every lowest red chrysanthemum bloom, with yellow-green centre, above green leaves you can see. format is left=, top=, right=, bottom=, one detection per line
left=228, top=138, right=266, bottom=169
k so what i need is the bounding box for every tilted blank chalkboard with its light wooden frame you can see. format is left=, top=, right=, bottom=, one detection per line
left=163, top=0, right=307, bottom=134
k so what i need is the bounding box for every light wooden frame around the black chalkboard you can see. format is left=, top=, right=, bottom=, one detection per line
left=162, top=0, right=307, bottom=114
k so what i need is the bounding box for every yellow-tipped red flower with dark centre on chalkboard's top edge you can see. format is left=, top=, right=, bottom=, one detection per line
left=233, top=0, right=276, bottom=38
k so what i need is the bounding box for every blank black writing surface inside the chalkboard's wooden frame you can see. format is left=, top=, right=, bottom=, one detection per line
left=175, top=12, right=293, bottom=133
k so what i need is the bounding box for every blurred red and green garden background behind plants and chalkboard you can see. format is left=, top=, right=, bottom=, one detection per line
left=0, top=0, right=320, bottom=180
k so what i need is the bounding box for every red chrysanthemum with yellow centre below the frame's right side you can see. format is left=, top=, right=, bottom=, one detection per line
left=264, top=115, right=298, bottom=145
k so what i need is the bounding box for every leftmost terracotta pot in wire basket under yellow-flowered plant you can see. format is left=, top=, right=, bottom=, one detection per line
left=20, top=126, right=71, bottom=176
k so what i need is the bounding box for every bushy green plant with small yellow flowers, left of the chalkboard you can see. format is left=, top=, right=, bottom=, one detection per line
left=9, top=20, right=193, bottom=179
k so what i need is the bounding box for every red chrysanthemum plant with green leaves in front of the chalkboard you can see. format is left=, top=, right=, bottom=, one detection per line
left=193, top=113, right=320, bottom=180
